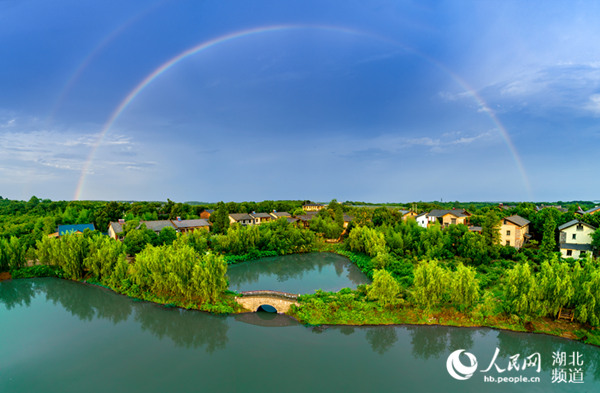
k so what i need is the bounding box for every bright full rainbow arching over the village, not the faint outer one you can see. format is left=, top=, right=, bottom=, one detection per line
left=74, top=25, right=533, bottom=200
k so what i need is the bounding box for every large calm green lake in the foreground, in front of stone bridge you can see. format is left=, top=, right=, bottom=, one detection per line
left=0, top=278, right=600, bottom=393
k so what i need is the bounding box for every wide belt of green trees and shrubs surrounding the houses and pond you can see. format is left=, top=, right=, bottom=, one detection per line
left=0, top=197, right=600, bottom=344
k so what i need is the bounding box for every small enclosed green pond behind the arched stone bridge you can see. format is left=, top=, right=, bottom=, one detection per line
left=227, top=253, right=370, bottom=293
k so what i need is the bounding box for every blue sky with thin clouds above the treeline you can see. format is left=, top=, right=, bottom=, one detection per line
left=0, top=0, right=600, bottom=202
